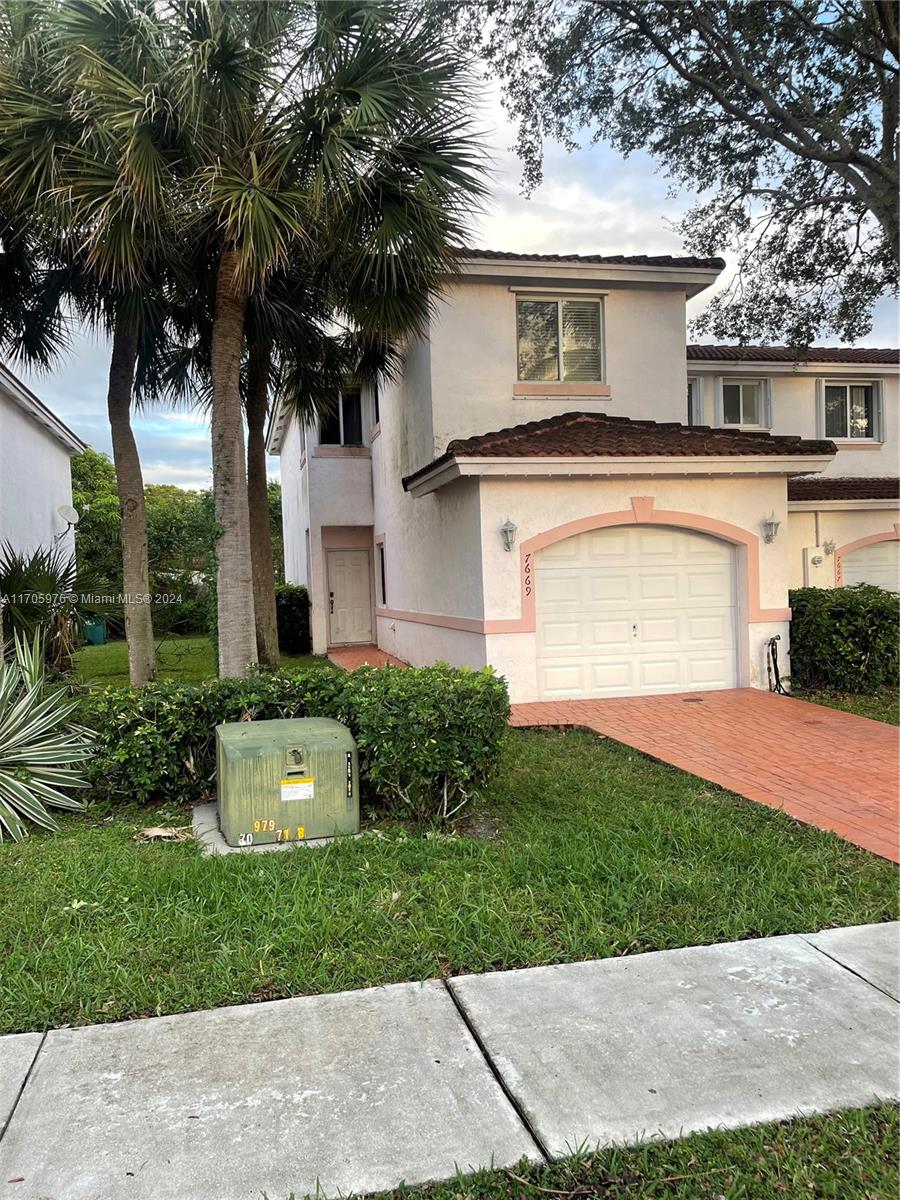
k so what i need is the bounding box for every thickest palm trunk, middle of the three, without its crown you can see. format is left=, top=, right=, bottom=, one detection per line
left=210, top=250, right=257, bottom=678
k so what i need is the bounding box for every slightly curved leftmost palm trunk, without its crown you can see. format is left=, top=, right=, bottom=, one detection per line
left=107, top=319, right=156, bottom=688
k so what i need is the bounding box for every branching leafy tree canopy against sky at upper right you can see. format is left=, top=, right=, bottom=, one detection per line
left=468, top=0, right=900, bottom=347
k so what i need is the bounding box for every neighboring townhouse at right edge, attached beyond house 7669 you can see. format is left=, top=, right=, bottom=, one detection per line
left=688, top=346, right=900, bottom=589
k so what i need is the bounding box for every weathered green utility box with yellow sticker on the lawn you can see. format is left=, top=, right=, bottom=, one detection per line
left=216, top=718, right=359, bottom=846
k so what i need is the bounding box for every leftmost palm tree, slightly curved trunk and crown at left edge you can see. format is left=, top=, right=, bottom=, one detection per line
left=0, top=0, right=183, bottom=685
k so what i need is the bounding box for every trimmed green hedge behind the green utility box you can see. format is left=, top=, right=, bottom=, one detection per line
left=82, top=664, right=509, bottom=820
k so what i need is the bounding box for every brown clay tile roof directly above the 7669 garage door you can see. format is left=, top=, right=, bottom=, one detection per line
left=403, top=413, right=836, bottom=487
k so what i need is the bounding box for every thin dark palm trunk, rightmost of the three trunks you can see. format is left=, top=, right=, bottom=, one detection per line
left=246, top=343, right=278, bottom=667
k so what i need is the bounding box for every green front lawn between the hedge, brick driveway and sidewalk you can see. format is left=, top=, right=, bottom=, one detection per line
left=0, top=731, right=898, bottom=1032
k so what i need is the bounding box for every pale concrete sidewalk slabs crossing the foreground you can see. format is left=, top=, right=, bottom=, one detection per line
left=0, top=924, right=900, bottom=1200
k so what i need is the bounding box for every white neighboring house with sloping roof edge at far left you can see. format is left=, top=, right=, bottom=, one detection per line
left=0, top=365, right=85, bottom=553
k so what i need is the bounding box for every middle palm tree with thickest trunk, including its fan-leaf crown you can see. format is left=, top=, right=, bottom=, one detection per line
left=160, top=0, right=482, bottom=676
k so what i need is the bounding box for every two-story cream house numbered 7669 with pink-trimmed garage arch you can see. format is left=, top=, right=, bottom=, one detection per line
left=269, top=251, right=896, bottom=701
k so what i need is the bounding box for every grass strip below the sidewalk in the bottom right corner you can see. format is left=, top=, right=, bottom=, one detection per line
left=326, top=1104, right=900, bottom=1200
